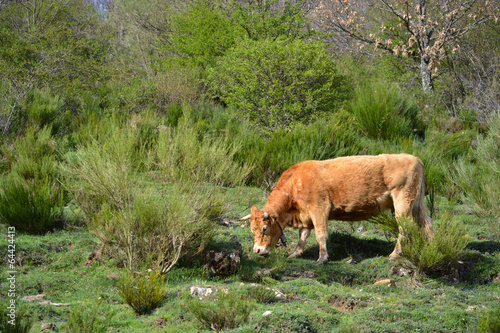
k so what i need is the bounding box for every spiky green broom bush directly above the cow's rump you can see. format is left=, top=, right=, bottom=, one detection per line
left=348, top=82, right=423, bottom=140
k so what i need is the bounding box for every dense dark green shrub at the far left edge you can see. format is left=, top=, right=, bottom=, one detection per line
left=0, top=127, right=68, bottom=234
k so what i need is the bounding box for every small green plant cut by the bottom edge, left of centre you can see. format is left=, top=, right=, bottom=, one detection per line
left=65, top=301, right=114, bottom=333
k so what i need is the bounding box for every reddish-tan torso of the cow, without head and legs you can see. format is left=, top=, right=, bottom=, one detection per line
left=277, top=154, right=423, bottom=221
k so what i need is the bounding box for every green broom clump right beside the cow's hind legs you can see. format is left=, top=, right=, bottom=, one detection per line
left=400, top=213, right=468, bottom=275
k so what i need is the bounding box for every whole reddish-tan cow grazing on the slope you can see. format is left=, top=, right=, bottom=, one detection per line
left=240, top=154, right=434, bottom=264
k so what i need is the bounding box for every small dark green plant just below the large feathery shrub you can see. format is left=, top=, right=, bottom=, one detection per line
left=118, top=270, right=166, bottom=315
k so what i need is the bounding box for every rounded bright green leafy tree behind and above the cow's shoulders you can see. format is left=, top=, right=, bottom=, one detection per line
left=207, top=39, right=349, bottom=132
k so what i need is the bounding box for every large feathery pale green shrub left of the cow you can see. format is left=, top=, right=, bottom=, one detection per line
left=68, top=113, right=249, bottom=273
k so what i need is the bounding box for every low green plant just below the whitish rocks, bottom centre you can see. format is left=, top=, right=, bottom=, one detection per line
left=186, top=291, right=252, bottom=331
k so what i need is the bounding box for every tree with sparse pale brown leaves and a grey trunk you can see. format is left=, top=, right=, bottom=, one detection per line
left=314, top=0, right=500, bottom=91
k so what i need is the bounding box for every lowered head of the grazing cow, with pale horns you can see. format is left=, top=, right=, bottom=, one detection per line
left=240, top=206, right=283, bottom=255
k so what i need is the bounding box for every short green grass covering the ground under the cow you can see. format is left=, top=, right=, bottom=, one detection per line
left=0, top=188, right=500, bottom=332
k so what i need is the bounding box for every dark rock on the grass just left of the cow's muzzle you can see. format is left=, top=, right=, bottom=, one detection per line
left=203, top=242, right=243, bottom=277
